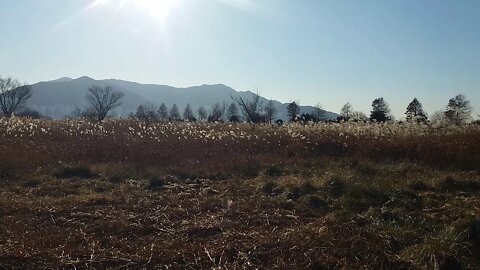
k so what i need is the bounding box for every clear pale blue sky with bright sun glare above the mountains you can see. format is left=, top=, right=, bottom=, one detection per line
left=0, top=0, right=480, bottom=118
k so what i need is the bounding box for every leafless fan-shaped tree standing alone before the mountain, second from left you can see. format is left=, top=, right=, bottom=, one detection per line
left=86, top=85, right=125, bottom=122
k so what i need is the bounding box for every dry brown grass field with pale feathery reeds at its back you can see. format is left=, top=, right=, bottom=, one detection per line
left=0, top=119, right=480, bottom=269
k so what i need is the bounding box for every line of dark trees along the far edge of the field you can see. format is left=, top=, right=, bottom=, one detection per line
left=0, top=77, right=479, bottom=125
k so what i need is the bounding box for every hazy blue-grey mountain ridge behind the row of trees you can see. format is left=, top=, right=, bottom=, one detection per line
left=28, top=76, right=338, bottom=120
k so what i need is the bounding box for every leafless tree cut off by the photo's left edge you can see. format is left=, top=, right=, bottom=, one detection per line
left=0, top=77, right=32, bottom=117
